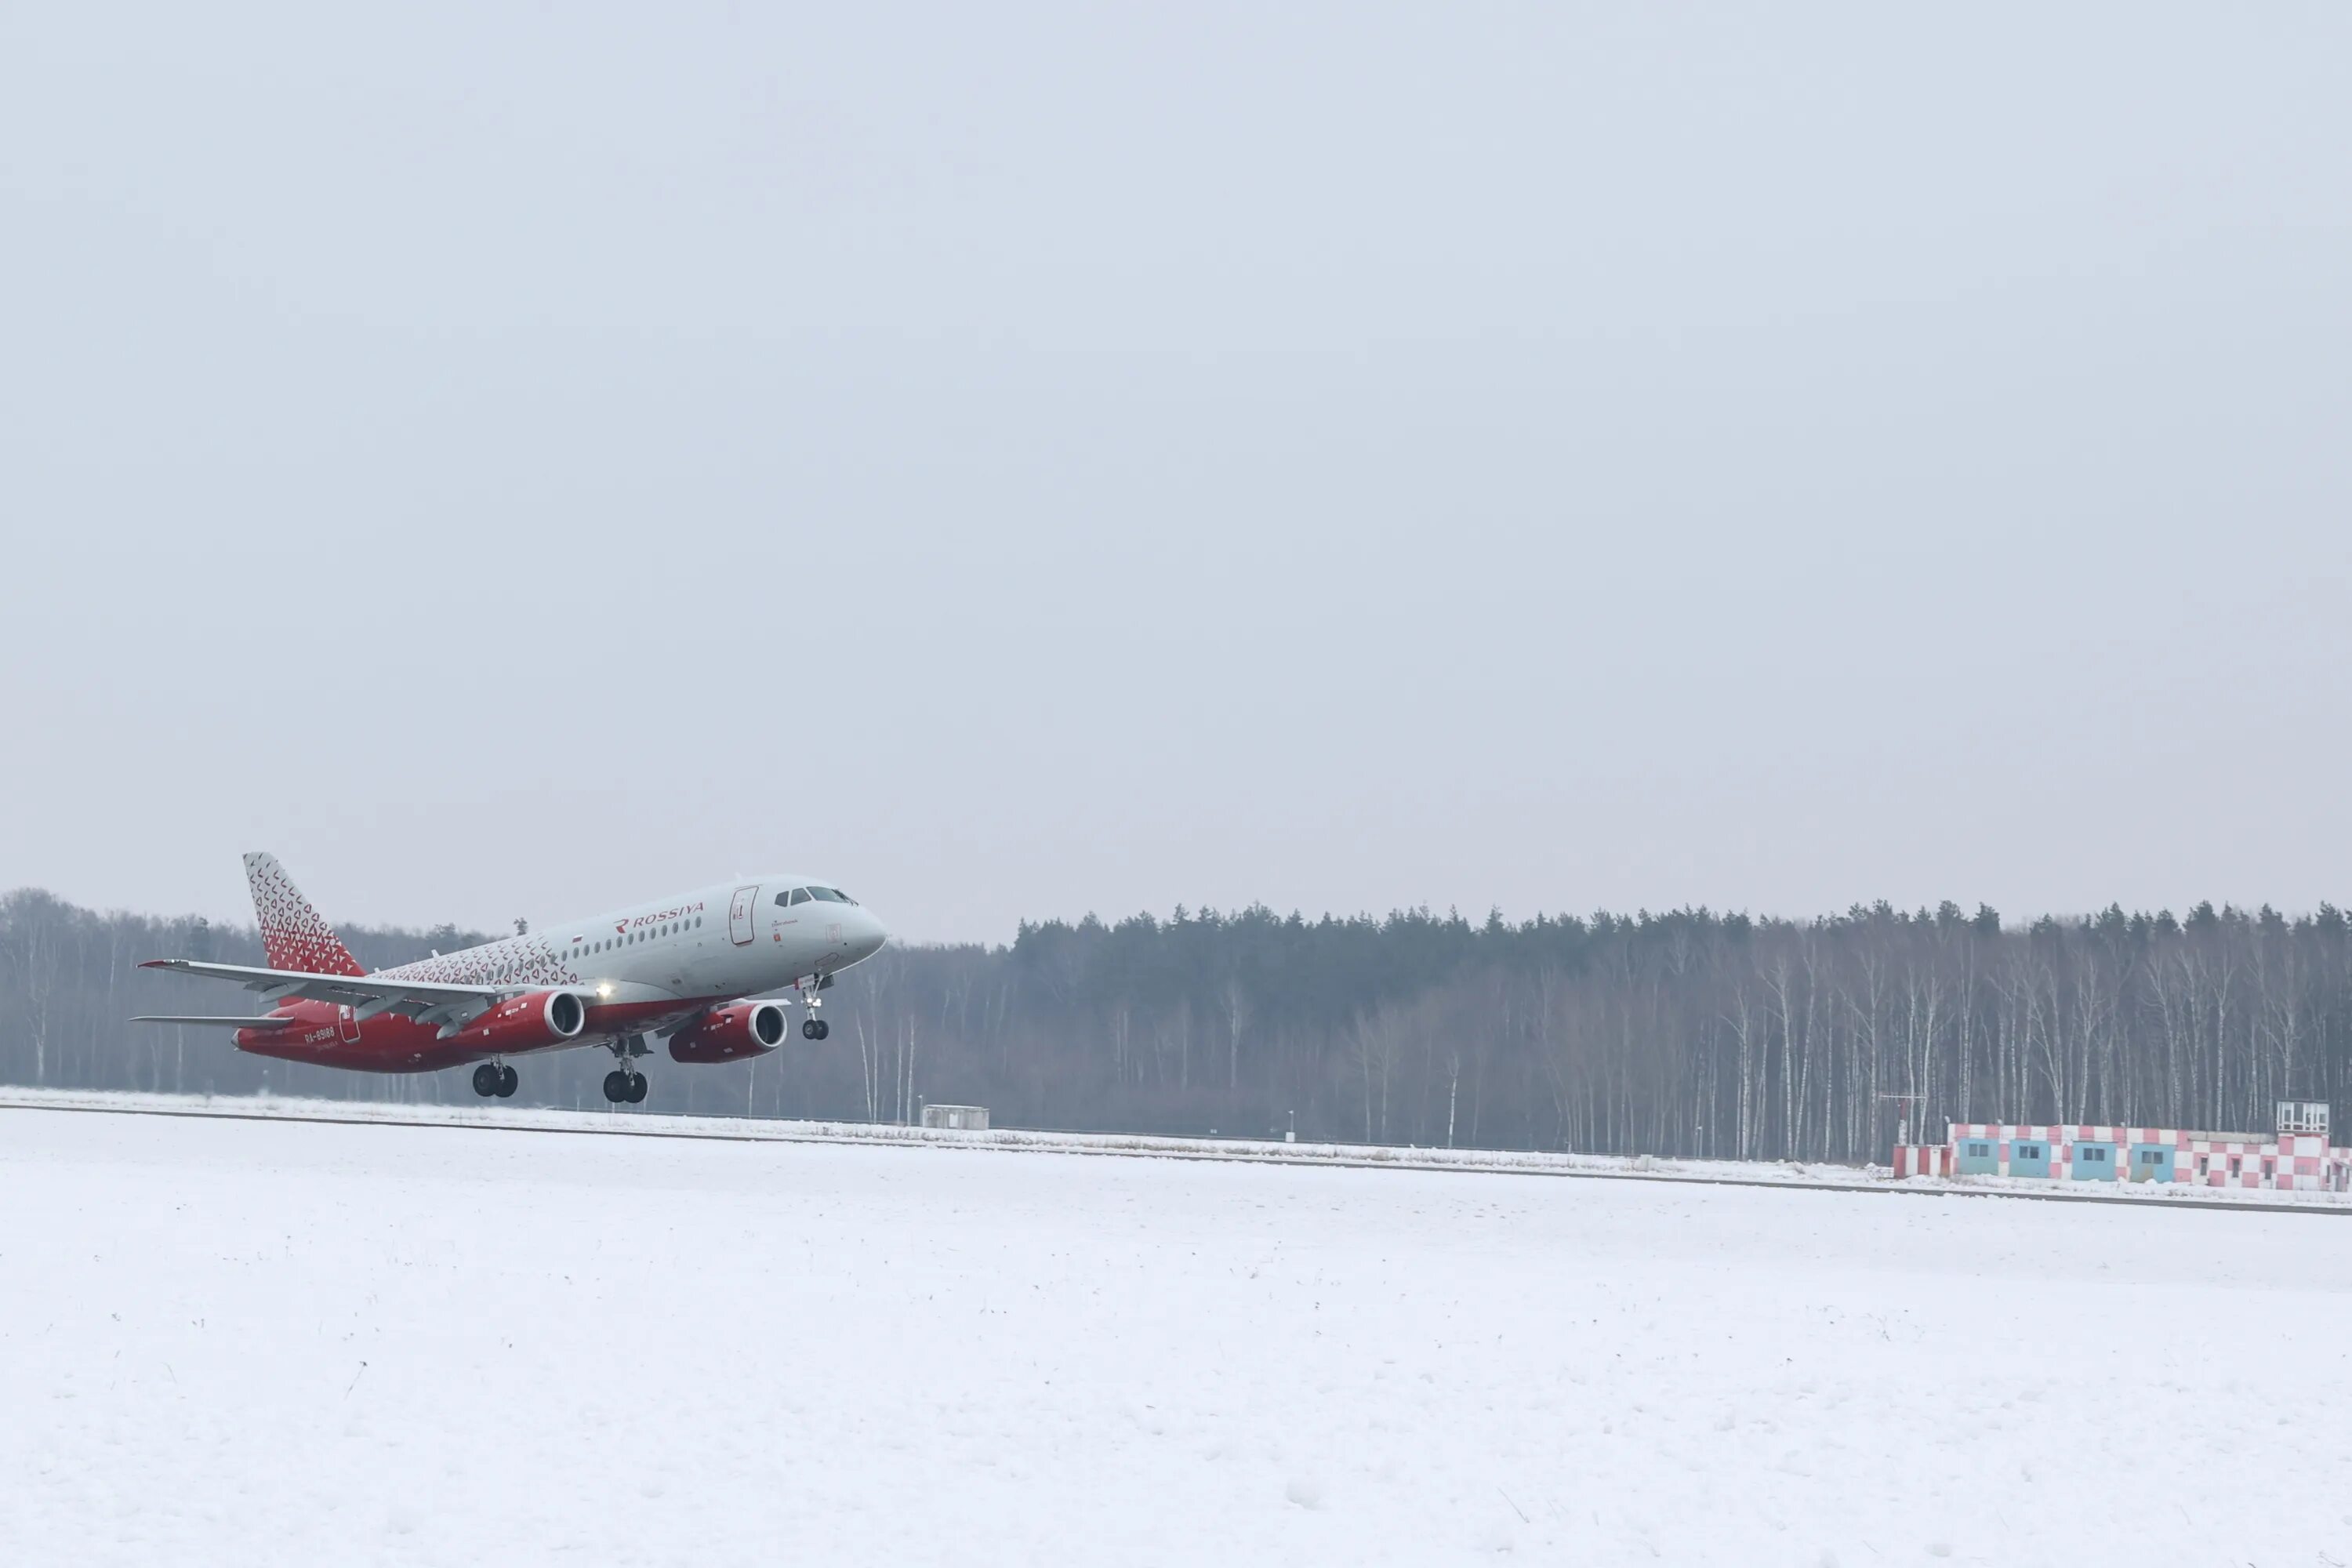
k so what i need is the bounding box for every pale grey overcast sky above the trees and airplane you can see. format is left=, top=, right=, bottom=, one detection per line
left=0, top=0, right=2352, bottom=940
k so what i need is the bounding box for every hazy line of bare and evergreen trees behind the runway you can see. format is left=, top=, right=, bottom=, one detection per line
left=0, top=891, right=2352, bottom=1161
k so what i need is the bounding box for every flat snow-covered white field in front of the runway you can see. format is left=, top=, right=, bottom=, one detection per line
left=0, top=1107, right=2352, bottom=1566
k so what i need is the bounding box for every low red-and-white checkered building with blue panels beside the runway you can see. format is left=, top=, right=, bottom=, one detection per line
left=1929, top=1100, right=2352, bottom=1192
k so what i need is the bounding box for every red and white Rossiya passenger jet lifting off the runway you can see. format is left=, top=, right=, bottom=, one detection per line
left=132, top=853, right=889, bottom=1105
